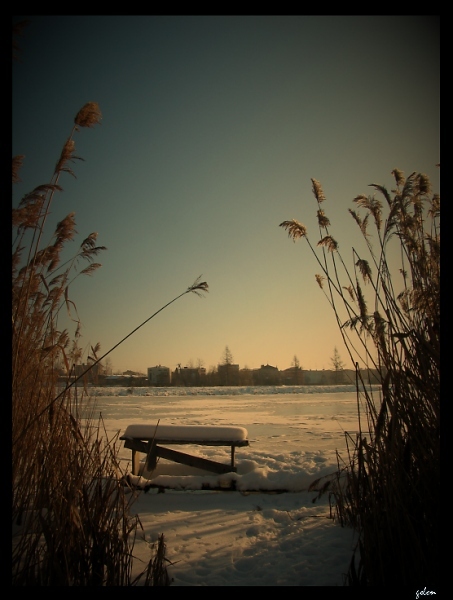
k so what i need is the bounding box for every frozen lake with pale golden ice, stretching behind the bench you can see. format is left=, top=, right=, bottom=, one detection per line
left=80, top=386, right=378, bottom=486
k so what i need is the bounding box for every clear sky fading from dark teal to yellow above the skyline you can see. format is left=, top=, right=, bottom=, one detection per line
left=12, top=15, right=440, bottom=372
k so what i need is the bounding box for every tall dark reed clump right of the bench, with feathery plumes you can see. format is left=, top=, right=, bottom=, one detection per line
left=280, top=169, right=441, bottom=590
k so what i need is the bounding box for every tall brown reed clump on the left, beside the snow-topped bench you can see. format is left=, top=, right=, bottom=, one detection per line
left=12, top=102, right=168, bottom=586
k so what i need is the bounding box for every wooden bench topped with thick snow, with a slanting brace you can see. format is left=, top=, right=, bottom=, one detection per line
left=120, top=423, right=249, bottom=475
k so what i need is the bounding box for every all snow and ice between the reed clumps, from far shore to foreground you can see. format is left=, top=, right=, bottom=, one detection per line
left=89, top=386, right=368, bottom=586
